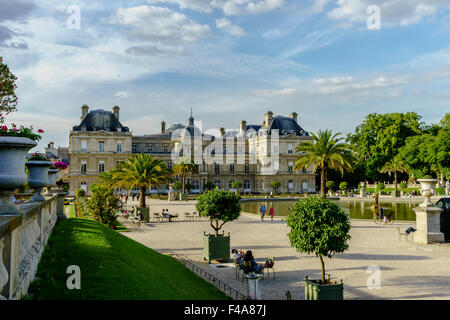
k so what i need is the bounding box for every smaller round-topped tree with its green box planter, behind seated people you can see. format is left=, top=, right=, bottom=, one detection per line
left=196, top=188, right=241, bottom=263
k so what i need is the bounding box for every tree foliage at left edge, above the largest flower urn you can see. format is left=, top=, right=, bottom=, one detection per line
left=0, top=57, right=18, bottom=123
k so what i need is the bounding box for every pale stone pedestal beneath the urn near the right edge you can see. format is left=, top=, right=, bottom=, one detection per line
left=413, top=204, right=444, bottom=244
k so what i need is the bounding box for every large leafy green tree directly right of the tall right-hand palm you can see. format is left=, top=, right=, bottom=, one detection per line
left=348, top=112, right=424, bottom=181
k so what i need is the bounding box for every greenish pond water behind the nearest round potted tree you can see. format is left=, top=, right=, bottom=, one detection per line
left=241, top=200, right=420, bottom=221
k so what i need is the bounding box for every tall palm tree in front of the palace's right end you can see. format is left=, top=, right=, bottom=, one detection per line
left=294, top=130, right=354, bottom=197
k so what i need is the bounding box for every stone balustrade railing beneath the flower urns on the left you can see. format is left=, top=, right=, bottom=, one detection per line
left=0, top=192, right=64, bottom=300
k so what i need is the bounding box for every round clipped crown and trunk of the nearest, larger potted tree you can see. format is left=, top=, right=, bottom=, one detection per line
left=287, top=197, right=351, bottom=284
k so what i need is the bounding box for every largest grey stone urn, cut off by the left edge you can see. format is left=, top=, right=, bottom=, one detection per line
left=0, top=136, right=36, bottom=214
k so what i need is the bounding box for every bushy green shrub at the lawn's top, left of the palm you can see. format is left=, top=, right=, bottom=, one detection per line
left=87, top=183, right=119, bottom=226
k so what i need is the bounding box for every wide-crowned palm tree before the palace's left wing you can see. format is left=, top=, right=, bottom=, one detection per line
left=113, top=153, right=171, bottom=207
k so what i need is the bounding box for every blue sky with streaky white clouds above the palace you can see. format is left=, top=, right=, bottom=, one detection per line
left=0, top=0, right=450, bottom=148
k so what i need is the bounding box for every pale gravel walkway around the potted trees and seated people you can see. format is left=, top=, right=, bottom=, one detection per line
left=119, top=199, right=450, bottom=300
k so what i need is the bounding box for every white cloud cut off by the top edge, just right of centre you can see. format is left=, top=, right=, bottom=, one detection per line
left=211, top=0, right=284, bottom=16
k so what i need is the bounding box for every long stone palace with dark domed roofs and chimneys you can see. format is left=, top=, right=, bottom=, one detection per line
left=69, top=105, right=316, bottom=196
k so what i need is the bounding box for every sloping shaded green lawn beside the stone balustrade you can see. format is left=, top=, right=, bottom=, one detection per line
left=26, top=219, right=230, bottom=300
